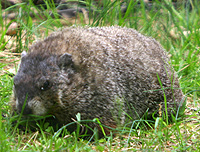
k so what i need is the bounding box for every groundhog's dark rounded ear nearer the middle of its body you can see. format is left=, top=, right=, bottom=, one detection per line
left=57, top=53, right=73, bottom=68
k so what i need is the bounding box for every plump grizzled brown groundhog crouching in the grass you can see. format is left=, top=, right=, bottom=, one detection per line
left=12, top=26, right=183, bottom=133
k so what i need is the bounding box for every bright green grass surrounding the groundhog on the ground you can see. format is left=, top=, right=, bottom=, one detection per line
left=0, top=0, right=200, bottom=152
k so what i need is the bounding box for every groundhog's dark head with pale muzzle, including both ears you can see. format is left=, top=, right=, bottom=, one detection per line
left=13, top=52, right=75, bottom=115
